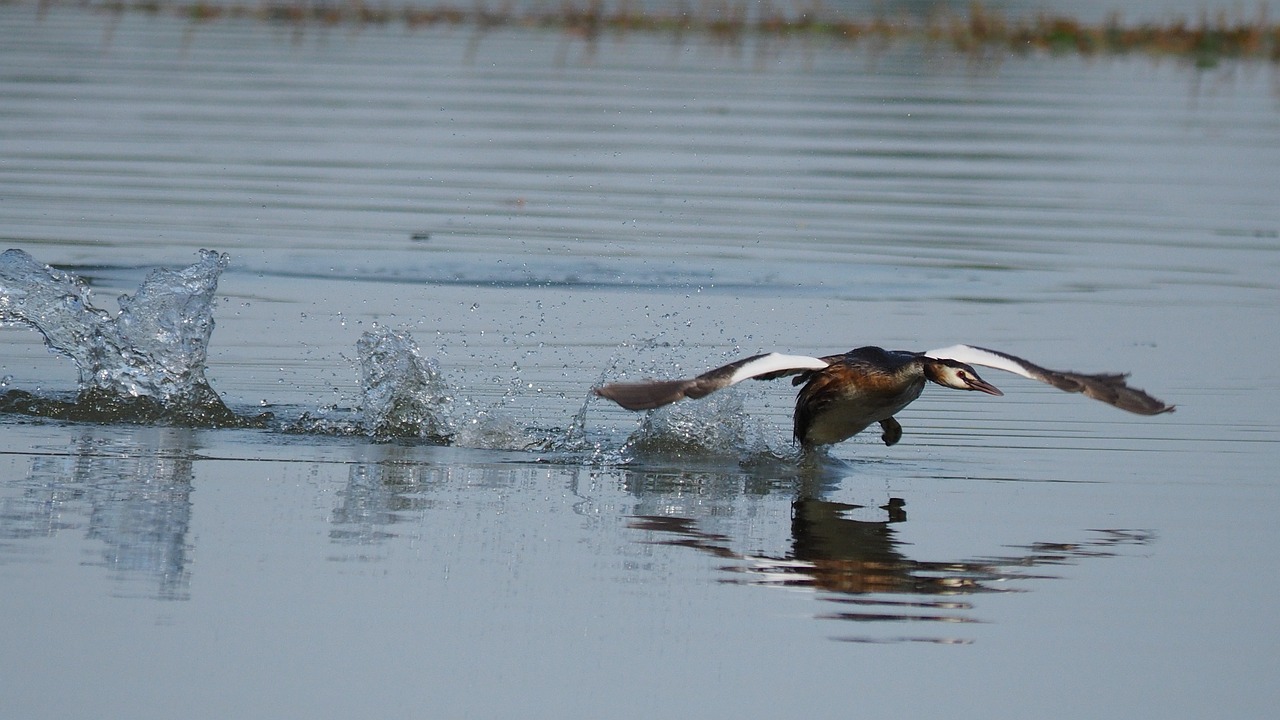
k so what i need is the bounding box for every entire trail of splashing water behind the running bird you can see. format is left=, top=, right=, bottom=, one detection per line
left=0, top=250, right=785, bottom=453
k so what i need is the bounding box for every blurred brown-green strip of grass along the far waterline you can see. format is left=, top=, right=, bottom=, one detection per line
left=22, top=0, right=1280, bottom=65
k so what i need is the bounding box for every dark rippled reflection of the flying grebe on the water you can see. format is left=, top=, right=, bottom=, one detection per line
left=632, top=489, right=1153, bottom=643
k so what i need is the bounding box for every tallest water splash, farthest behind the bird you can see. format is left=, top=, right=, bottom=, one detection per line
left=0, top=250, right=249, bottom=427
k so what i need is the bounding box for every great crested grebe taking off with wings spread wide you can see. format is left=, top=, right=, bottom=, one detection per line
left=595, top=345, right=1174, bottom=448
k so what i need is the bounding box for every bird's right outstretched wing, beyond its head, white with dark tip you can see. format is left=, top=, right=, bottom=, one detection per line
left=924, top=345, right=1174, bottom=415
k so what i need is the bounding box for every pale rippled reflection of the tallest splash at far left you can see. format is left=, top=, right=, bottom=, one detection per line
left=0, top=427, right=192, bottom=600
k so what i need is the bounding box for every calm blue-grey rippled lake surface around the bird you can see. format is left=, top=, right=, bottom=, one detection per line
left=0, top=5, right=1280, bottom=719
